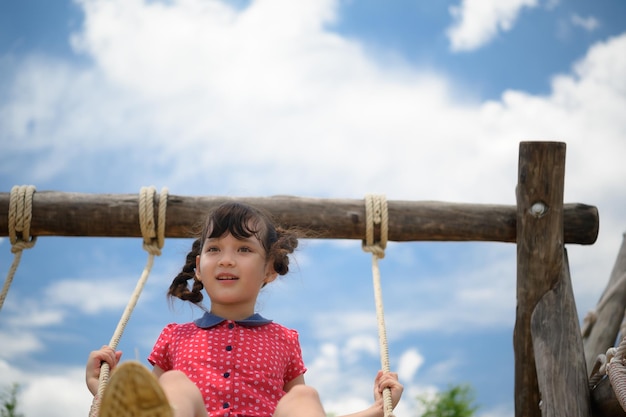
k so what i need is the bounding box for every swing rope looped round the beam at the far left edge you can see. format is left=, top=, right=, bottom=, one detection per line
left=0, top=185, right=37, bottom=310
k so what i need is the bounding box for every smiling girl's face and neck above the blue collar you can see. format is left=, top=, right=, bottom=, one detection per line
left=196, top=233, right=278, bottom=320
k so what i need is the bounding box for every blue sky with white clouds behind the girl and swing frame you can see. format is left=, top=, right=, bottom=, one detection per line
left=0, top=0, right=626, bottom=417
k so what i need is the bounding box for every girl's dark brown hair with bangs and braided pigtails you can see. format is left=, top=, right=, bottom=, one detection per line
left=167, top=202, right=298, bottom=304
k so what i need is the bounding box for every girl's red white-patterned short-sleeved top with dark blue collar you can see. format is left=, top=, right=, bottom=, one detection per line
left=148, top=313, right=306, bottom=417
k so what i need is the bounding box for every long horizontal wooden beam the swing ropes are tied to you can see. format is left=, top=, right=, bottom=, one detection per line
left=0, top=191, right=599, bottom=245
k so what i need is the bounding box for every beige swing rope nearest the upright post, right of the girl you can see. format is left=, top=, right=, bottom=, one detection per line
left=362, top=194, right=393, bottom=417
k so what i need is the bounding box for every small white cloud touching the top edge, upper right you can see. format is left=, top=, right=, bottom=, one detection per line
left=447, top=0, right=538, bottom=52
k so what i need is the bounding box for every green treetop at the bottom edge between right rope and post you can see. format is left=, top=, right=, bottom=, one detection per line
left=417, top=384, right=478, bottom=417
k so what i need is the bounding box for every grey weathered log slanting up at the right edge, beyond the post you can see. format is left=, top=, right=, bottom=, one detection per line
left=583, top=234, right=626, bottom=372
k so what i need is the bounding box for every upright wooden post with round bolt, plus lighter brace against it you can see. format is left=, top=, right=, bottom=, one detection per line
left=513, top=142, right=591, bottom=417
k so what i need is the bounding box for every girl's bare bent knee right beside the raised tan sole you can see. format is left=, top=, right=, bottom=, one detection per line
left=159, top=371, right=207, bottom=417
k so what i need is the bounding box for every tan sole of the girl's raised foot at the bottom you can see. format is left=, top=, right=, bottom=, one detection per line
left=100, top=361, right=174, bottom=417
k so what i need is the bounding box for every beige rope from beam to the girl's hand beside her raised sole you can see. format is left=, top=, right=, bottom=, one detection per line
left=89, top=186, right=168, bottom=417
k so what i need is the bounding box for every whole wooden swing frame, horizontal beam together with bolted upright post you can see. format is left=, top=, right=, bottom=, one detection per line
left=0, top=142, right=626, bottom=417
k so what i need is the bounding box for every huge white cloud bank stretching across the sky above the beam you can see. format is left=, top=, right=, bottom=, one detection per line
left=0, top=1, right=623, bottom=211
